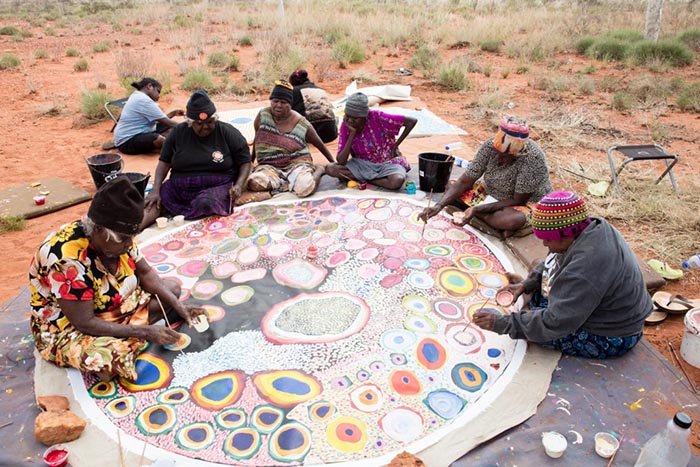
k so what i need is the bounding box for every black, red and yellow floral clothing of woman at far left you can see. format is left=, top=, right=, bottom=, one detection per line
left=29, top=222, right=150, bottom=381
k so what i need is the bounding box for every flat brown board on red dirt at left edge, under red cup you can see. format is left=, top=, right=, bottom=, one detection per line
left=0, top=177, right=92, bottom=219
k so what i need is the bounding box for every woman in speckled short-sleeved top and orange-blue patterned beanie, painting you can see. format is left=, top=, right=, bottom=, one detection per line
left=419, top=115, right=552, bottom=235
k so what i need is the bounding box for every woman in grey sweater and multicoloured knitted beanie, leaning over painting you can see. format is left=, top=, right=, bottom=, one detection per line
left=474, top=192, right=653, bottom=358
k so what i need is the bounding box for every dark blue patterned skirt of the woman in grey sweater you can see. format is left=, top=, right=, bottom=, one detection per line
left=530, top=291, right=643, bottom=359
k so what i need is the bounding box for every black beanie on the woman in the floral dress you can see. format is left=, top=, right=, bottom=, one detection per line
left=88, top=175, right=143, bottom=235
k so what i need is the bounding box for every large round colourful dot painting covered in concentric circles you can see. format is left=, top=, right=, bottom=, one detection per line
left=71, top=195, right=526, bottom=466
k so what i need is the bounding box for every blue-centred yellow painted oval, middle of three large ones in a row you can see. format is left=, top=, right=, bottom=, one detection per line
left=190, top=370, right=246, bottom=411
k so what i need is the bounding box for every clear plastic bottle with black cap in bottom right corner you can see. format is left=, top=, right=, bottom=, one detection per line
left=634, top=412, right=693, bottom=467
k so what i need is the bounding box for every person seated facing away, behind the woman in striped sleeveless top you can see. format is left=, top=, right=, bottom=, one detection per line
left=289, top=70, right=338, bottom=143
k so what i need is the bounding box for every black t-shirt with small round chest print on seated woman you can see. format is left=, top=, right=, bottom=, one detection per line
left=160, top=122, right=250, bottom=179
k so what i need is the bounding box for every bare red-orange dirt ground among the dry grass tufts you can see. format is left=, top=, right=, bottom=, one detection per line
left=0, top=8, right=700, bottom=432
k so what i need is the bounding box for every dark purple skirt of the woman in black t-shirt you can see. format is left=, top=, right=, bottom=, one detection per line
left=160, top=175, right=234, bottom=219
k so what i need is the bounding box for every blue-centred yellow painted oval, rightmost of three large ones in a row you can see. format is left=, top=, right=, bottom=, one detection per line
left=253, top=370, right=323, bottom=408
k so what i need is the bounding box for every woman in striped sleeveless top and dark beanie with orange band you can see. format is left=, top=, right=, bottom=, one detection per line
left=248, top=80, right=333, bottom=198
